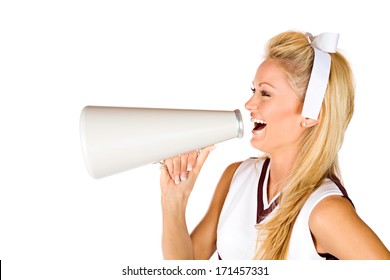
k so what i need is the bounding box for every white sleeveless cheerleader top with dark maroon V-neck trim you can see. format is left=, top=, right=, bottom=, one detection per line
left=217, top=158, right=352, bottom=260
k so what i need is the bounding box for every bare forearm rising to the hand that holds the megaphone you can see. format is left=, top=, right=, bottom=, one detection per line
left=162, top=202, right=194, bottom=260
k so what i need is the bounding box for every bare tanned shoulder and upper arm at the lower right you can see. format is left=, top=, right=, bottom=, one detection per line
left=309, top=195, right=390, bottom=259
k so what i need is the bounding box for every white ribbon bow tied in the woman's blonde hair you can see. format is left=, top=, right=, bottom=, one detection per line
left=302, top=32, right=339, bottom=120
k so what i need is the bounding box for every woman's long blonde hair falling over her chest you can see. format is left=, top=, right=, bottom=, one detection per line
left=255, top=31, right=355, bottom=260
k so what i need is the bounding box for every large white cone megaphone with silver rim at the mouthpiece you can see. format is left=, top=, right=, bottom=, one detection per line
left=80, top=106, right=243, bottom=178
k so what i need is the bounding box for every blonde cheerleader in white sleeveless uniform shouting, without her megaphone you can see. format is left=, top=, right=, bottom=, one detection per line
left=161, top=32, right=390, bottom=260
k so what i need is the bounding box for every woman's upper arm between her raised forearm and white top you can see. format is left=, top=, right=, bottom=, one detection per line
left=191, top=162, right=241, bottom=259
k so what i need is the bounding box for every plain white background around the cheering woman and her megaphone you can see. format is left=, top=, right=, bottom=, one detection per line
left=0, top=0, right=390, bottom=279
